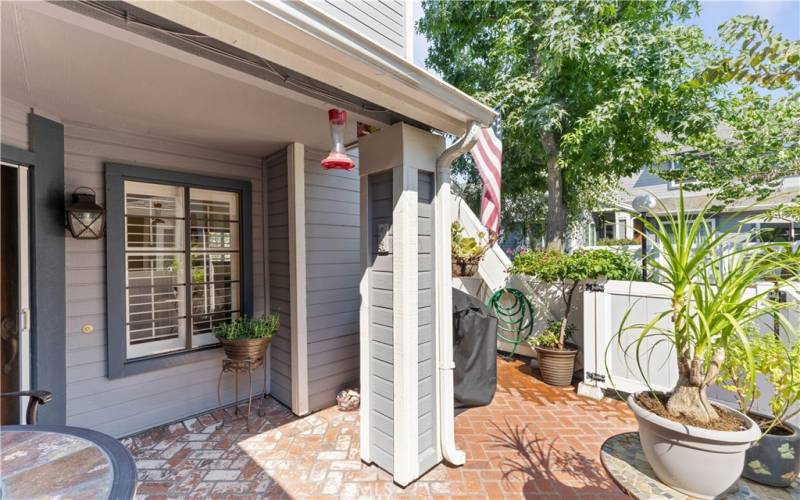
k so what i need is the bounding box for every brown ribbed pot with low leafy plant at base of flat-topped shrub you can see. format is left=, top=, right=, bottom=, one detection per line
left=528, top=321, right=578, bottom=387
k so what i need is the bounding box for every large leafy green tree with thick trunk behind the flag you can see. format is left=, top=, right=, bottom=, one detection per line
left=418, top=0, right=714, bottom=249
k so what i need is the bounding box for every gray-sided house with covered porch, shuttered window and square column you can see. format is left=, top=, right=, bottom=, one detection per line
left=0, top=0, right=494, bottom=484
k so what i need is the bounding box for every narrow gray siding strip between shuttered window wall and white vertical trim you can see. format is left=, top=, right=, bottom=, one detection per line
left=264, top=149, right=292, bottom=408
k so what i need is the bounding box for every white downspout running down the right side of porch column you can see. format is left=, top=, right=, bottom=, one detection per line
left=434, top=121, right=481, bottom=465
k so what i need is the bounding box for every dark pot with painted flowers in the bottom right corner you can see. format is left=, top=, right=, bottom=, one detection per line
left=742, top=415, right=800, bottom=488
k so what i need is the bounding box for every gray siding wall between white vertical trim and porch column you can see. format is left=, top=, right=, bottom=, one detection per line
left=305, top=148, right=361, bottom=411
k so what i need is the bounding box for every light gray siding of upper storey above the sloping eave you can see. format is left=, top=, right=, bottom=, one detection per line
left=311, top=0, right=407, bottom=56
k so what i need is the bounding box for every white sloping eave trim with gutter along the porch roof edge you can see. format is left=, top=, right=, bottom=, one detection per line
left=130, top=0, right=496, bottom=135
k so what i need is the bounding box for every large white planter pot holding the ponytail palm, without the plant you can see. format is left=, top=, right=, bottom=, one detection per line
left=628, top=395, right=761, bottom=498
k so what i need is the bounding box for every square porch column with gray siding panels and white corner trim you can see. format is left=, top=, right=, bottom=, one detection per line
left=359, top=123, right=446, bottom=486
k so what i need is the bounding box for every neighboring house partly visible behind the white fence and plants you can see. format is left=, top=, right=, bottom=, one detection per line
left=581, top=167, right=800, bottom=246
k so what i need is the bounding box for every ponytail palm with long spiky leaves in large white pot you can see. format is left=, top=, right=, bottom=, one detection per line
left=617, top=191, right=800, bottom=498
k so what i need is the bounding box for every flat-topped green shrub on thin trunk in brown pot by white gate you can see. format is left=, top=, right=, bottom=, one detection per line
left=509, top=249, right=638, bottom=386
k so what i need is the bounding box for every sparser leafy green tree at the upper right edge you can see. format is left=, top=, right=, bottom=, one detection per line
left=659, top=16, right=800, bottom=202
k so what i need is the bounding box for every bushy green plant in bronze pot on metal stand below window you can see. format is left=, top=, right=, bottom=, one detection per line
left=214, top=314, right=279, bottom=361
